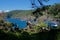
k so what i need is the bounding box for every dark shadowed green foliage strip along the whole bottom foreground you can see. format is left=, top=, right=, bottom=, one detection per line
left=0, top=29, right=60, bottom=40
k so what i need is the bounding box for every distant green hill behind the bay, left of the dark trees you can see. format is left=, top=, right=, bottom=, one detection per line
left=4, top=10, right=33, bottom=18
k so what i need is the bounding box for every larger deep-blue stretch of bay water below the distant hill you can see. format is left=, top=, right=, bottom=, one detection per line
left=5, top=18, right=27, bottom=28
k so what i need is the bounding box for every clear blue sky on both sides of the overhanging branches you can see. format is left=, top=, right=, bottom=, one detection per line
left=0, top=0, right=60, bottom=10
